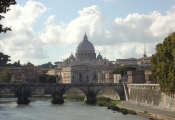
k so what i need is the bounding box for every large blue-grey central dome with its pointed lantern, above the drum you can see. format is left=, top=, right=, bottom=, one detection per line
left=76, top=34, right=95, bottom=53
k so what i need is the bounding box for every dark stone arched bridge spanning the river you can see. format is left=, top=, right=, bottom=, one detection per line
left=0, top=83, right=125, bottom=104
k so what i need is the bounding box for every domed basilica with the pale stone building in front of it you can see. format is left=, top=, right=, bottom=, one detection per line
left=58, top=34, right=113, bottom=83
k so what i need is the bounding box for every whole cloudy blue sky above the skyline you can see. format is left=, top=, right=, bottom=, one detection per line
left=0, top=0, right=175, bottom=65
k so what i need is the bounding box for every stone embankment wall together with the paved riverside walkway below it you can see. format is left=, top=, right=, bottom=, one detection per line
left=121, top=84, right=175, bottom=120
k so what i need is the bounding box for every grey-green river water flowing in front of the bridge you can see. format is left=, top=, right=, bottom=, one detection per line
left=0, top=98, right=148, bottom=120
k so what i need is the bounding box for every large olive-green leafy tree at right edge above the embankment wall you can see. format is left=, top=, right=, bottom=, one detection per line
left=151, top=33, right=175, bottom=95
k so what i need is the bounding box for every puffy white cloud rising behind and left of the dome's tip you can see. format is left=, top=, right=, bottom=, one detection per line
left=40, top=5, right=105, bottom=44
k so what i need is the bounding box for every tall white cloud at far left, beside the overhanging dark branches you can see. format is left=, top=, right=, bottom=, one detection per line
left=0, top=1, right=47, bottom=61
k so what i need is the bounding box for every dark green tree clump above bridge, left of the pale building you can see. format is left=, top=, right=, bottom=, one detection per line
left=38, top=74, right=57, bottom=83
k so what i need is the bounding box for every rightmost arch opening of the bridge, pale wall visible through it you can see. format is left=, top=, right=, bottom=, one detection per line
left=96, top=87, right=120, bottom=100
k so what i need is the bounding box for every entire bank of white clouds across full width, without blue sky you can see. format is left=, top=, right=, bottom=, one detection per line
left=0, top=1, right=175, bottom=64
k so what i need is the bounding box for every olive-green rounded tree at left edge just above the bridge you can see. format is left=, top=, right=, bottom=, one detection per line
left=0, top=68, right=12, bottom=83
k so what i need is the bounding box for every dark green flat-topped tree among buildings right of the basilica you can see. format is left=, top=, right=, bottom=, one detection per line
left=113, top=66, right=136, bottom=76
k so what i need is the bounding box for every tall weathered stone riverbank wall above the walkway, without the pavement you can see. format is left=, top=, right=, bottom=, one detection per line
left=127, top=84, right=175, bottom=109
